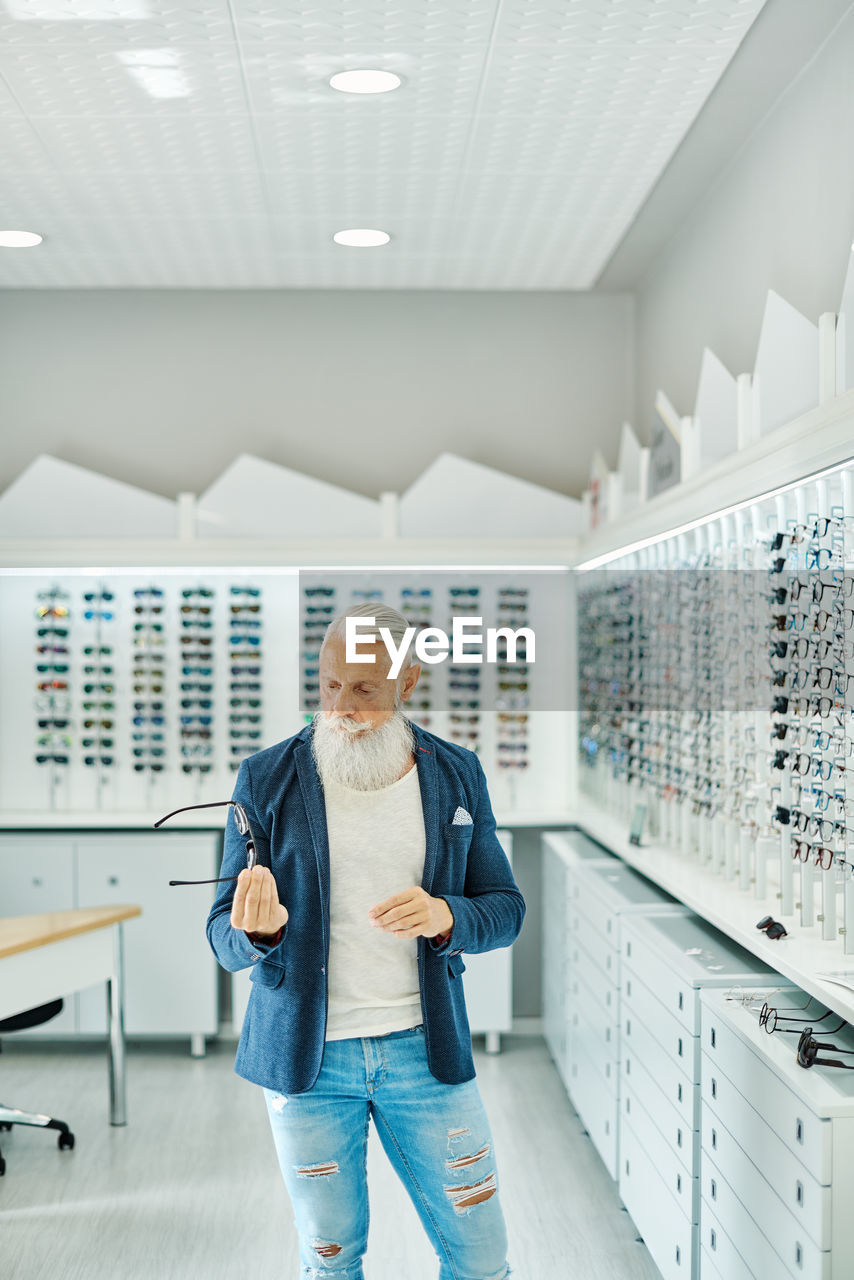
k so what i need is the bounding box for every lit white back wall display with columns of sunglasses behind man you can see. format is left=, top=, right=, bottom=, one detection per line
left=0, top=568, right=571, bottom=820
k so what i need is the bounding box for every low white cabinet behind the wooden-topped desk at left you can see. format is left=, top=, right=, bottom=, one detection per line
left=0, top=831, right=222, bottom=1046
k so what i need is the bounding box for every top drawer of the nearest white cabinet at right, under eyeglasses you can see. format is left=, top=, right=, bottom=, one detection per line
left=702, top=1010, right=831, bottom=1185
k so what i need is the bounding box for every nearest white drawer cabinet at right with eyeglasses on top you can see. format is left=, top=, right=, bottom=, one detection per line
left=700, top=987, right=854, bottom=1280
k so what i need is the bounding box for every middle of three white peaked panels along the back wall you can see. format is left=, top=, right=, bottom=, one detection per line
left=196, top=453, right=382, bottom=538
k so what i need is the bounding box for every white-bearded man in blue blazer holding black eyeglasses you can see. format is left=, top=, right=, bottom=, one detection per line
left=207, top=604, right=525, bottom=1280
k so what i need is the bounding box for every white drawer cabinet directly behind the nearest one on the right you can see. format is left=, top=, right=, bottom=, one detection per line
left=618, top=908, right=778, bottom=1280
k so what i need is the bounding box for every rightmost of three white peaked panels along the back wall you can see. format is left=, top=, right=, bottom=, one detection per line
left=399, top=453, right=585, bottom=538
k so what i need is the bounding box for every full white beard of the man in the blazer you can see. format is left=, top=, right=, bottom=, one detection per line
left=311, top=705, right=415, bottom=791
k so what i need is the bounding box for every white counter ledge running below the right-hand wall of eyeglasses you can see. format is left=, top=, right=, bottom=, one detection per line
left=575, top=799, right=854, bottom=1021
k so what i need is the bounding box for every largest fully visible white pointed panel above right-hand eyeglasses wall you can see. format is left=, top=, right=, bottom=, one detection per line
left=755, top=289, right=818, bottom=435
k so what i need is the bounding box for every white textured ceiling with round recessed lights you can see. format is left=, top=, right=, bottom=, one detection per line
left=0, top=0, right=764, bottom=289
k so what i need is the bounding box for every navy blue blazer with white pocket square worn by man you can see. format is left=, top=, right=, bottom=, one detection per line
left=206, top=723, right=525, bottom=1093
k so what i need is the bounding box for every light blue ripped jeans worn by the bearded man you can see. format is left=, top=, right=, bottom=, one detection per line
left=264, top=1027, right=510, bottom=1280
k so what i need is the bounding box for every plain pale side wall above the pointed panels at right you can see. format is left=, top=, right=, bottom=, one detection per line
left=634, top=1, right=854, bottom=438
